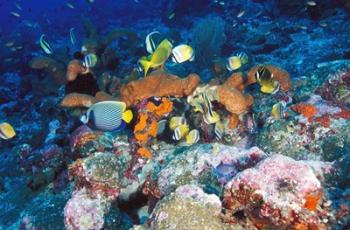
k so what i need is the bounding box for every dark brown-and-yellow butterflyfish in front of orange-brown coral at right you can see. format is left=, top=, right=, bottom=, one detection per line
left=255, top=66, right=280, bottom=94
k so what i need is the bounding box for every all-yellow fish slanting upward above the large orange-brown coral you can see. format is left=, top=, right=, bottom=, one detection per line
left=139, top=39, right=173, bottom=76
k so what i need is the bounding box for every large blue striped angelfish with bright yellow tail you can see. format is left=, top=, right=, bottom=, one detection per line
left=81, top=101, right=132, bottom=131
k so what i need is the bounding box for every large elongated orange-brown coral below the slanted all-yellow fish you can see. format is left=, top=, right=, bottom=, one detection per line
left=120, top=72, right=200, bottom=106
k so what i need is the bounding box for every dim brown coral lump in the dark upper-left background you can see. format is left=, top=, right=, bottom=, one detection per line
left=29, top=57, right=66, bottom=85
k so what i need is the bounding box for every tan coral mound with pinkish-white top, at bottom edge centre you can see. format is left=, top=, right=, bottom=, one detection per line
left=144, top=185, right=230, bottom=230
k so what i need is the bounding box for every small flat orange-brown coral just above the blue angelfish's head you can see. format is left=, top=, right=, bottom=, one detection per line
left=61, top=93, right=97, bottom=108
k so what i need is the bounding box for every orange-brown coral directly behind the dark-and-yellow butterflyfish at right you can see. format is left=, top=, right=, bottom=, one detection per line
left=246, top=65, right=292, bottom=92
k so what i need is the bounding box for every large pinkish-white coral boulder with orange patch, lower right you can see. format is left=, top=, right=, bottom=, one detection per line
left=224, top=155, right=326, bottom=229
